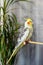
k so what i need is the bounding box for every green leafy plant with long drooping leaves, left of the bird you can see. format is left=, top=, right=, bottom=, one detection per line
left=0, top=0, right=26, bottom=65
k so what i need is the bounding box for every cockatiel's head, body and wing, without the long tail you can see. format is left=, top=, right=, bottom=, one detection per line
left=18, top=19, right=33, bottom=43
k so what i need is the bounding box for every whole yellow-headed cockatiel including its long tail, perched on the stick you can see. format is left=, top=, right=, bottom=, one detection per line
left=7, top=18, right=33, bottom=64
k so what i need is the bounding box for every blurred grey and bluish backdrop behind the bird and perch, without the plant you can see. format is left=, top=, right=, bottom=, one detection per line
left=13, top=0, right=43, bottom=65
